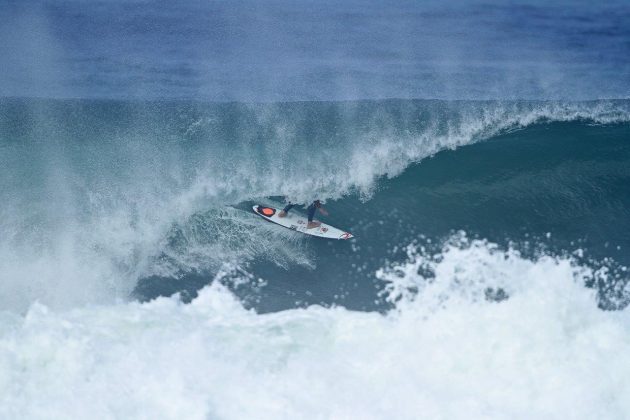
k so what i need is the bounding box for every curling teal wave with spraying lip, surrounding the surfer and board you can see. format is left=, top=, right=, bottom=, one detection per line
left=2, top=100, right=630, bottom=311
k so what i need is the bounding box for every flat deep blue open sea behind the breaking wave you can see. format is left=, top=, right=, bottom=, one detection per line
left=0, top=0, right=630, bottom=101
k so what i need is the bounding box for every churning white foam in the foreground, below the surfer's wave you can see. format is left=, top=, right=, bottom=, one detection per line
left=0, top=241, right=630, bottom=419
